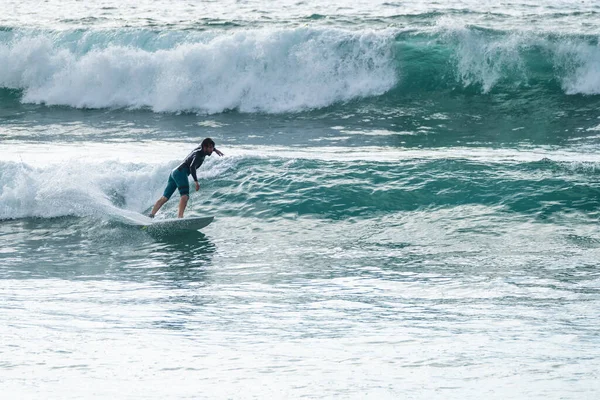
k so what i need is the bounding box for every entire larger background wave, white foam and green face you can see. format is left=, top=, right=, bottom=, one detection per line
left=0, top=24, right=600, bottom=114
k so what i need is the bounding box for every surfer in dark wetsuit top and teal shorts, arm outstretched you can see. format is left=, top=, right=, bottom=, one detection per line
left=149, top=138, right=223, bottom=218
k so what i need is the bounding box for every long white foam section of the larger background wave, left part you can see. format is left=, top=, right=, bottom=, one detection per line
left=0, top=28, right=397, bottom=113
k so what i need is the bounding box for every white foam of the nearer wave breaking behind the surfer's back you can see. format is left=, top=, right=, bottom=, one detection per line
left=0, top=160, right=170, bottom=219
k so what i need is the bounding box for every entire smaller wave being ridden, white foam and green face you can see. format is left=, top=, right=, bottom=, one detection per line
left=0, top=152, right=598, bottom=219
